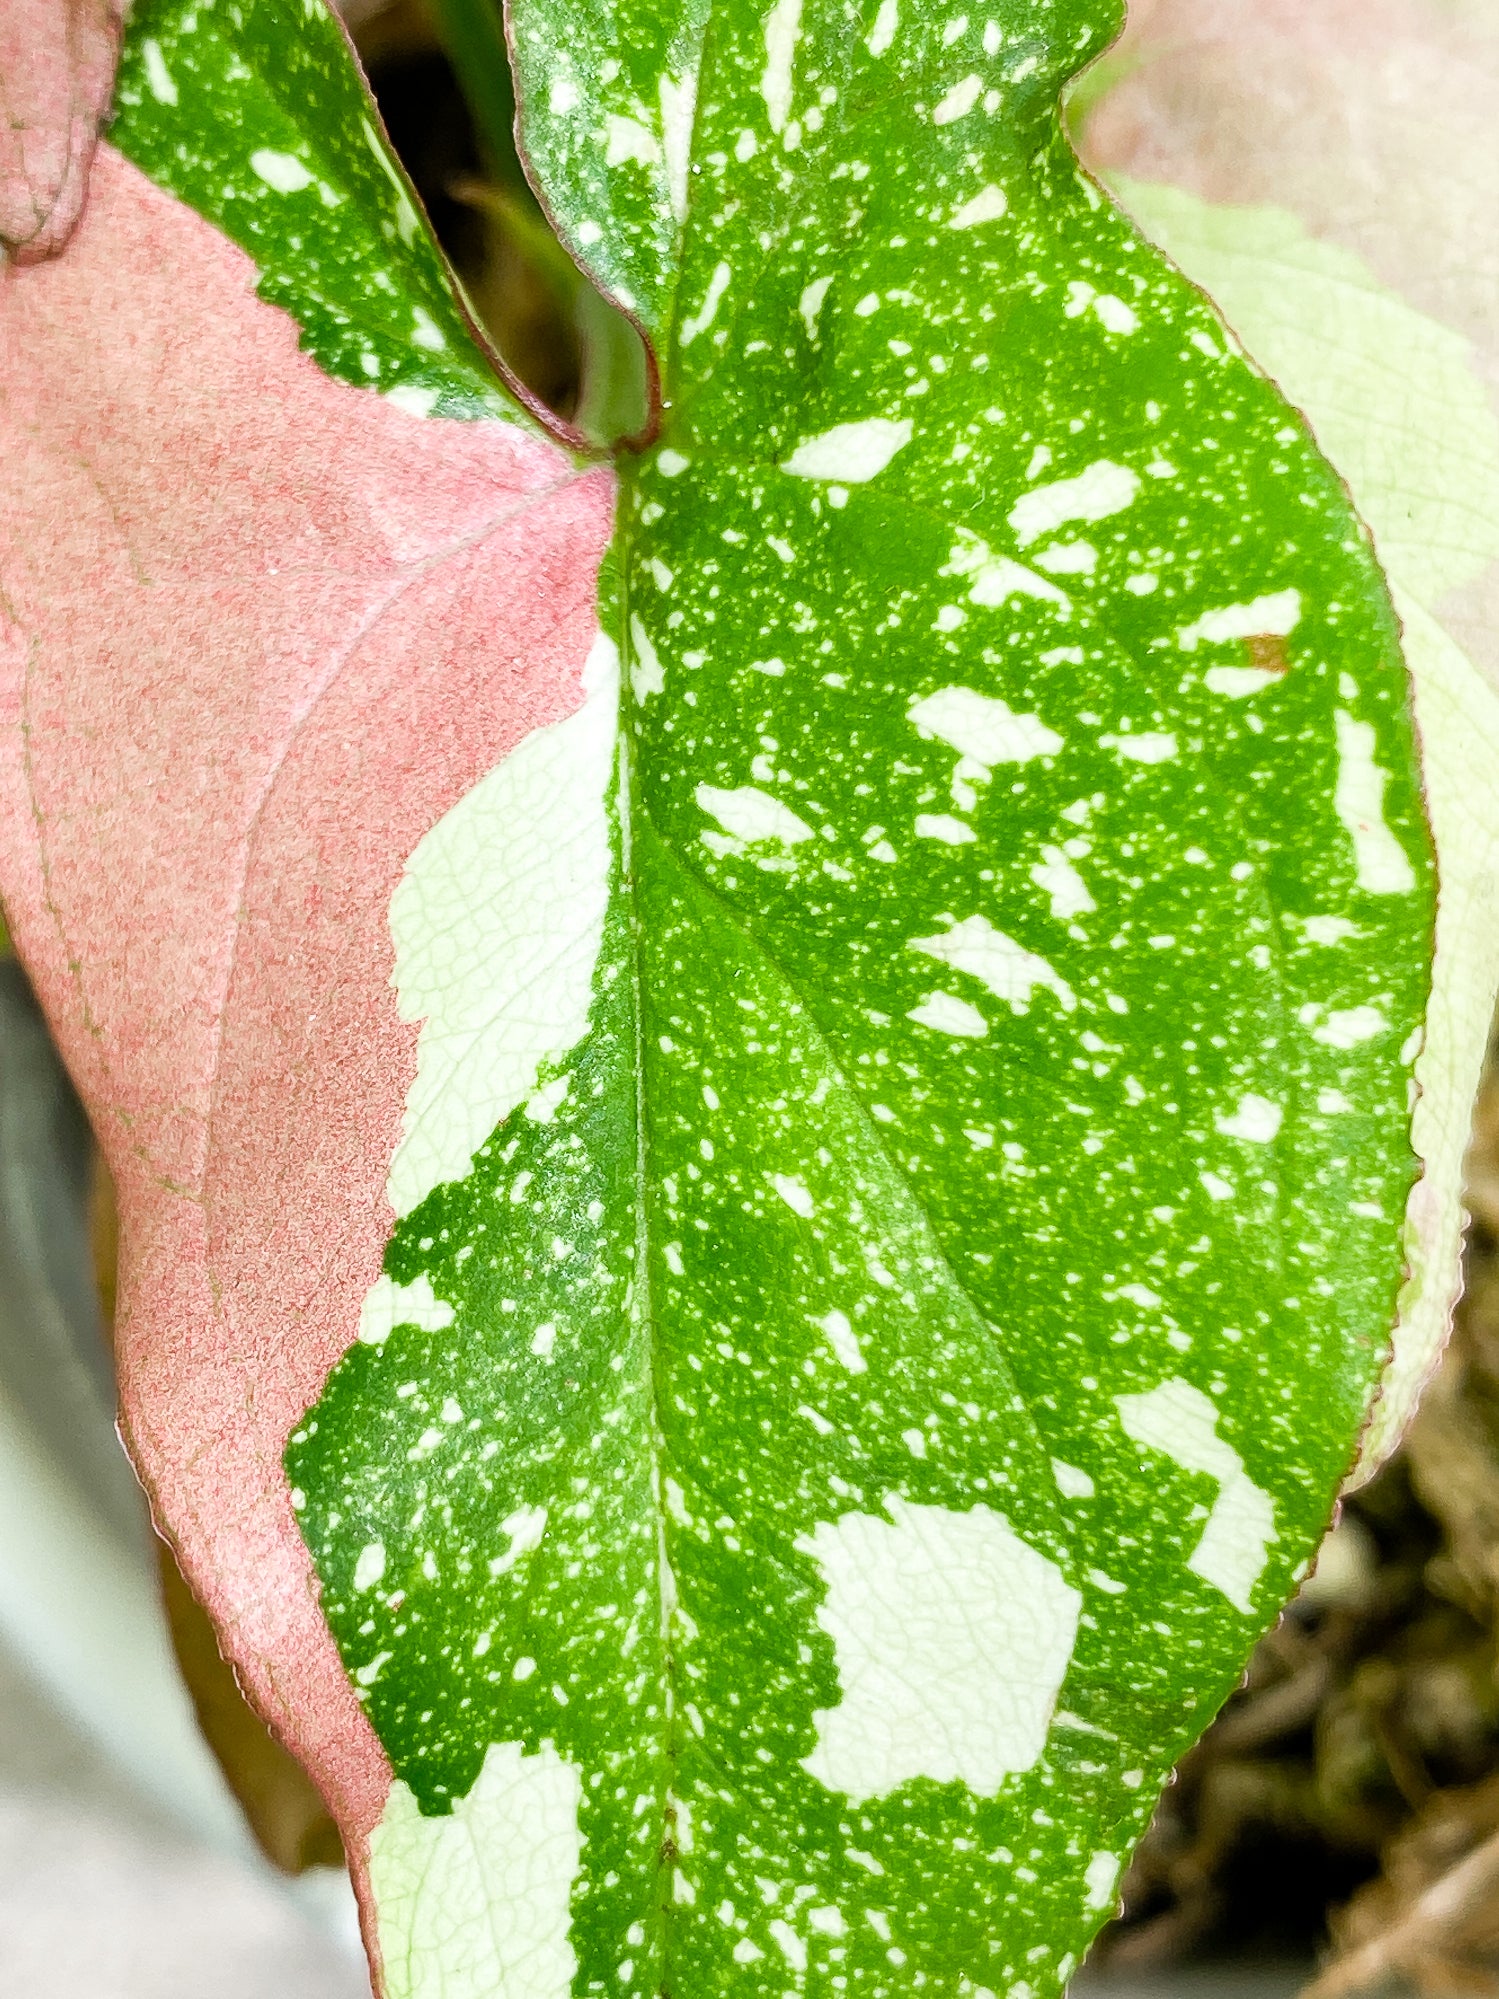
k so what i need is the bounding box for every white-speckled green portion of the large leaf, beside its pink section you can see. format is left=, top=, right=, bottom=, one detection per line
left=114, top=0, right=1433, bottom=1999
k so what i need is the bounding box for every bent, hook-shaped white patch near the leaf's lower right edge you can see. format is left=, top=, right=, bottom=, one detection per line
left=1113, top=1375, right=1275, bottom=1617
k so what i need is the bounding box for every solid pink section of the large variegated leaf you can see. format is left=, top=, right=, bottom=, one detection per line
left=0, top=146, right=612, bottom=1903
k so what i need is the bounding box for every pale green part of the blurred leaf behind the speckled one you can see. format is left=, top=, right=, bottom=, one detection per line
left=1087, top=174, right=1499, bottom=1477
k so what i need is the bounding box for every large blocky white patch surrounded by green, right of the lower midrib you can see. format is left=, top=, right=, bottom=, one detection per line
left=795, top=1495, right=1083, bottom=1803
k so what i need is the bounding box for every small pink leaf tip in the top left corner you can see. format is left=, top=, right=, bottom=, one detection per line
left=0, top=0, right=124, bottom=264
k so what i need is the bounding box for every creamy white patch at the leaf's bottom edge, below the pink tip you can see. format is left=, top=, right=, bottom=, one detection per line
left=370, top=1743, right=584, bottom=1999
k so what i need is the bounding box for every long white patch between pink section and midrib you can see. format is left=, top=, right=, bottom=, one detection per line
left=388, top=634, right=620, bottom=1215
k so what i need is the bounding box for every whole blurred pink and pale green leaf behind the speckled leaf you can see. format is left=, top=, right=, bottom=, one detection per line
left=1075, top=0, right=1499, bottom=1477
